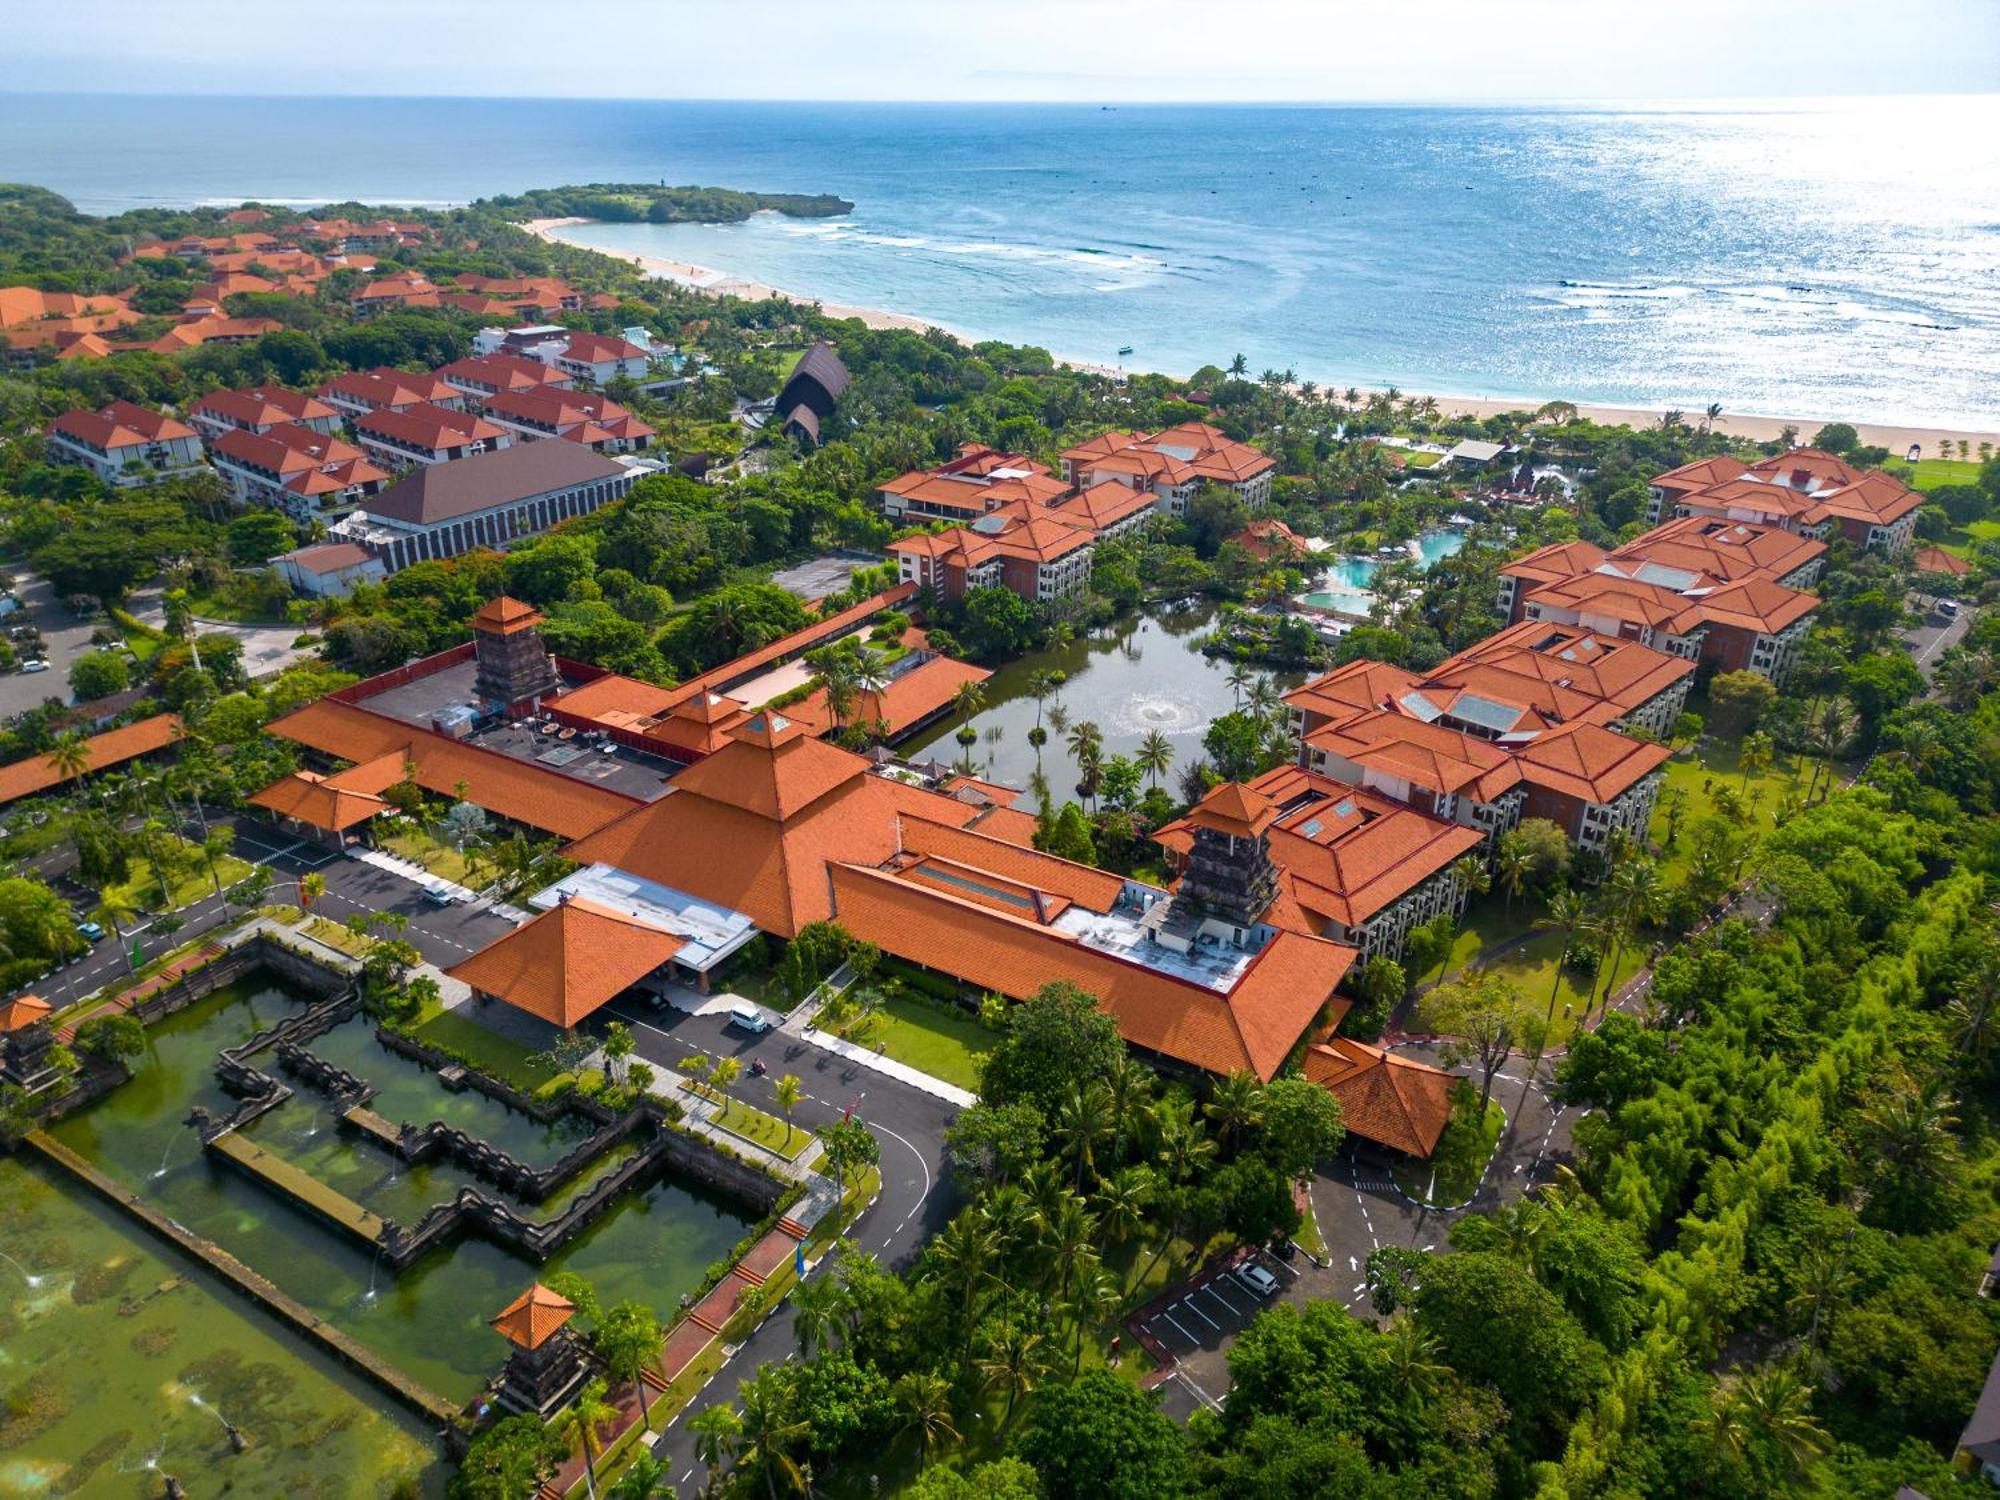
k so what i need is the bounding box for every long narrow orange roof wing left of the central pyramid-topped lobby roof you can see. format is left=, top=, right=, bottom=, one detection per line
left=266, top=698, right=642, bottom=838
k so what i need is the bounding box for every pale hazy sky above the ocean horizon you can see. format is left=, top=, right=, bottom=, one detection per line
left=11, top=0, right=2000, bottom=102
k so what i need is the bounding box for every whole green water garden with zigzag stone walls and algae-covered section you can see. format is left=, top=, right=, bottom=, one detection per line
left=0, top=966, right=784, bottom=1496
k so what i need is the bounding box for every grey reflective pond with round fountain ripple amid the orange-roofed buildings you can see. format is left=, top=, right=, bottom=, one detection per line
left=898, top=604, right=1304, bottom=802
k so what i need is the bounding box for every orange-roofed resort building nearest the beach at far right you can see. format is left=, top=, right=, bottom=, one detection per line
left=1648, top=448, right=1922, bottom=556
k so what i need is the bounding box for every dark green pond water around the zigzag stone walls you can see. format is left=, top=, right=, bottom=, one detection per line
left=52, top=976, right=752, bottom=1400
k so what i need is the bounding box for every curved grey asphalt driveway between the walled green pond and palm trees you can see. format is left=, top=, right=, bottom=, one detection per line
left=614, top=1006, right=956, bottom=1496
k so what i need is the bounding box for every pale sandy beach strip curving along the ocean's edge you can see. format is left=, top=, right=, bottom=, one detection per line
left=520, top=218, right=2000, bottom=458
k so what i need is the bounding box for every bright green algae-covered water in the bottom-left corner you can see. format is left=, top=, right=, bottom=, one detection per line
left=0, top=1160, right=444, bottom=1500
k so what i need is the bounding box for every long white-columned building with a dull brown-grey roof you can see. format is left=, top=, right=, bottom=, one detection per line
left=330, top=434, right=644, bottom=572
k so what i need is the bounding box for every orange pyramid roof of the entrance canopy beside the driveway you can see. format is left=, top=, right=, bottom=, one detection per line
left=444, top=896, right=686, bottom=1030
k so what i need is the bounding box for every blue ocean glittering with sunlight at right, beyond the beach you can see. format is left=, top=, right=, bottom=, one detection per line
left=0, top=96, right=2000, bottom=430
